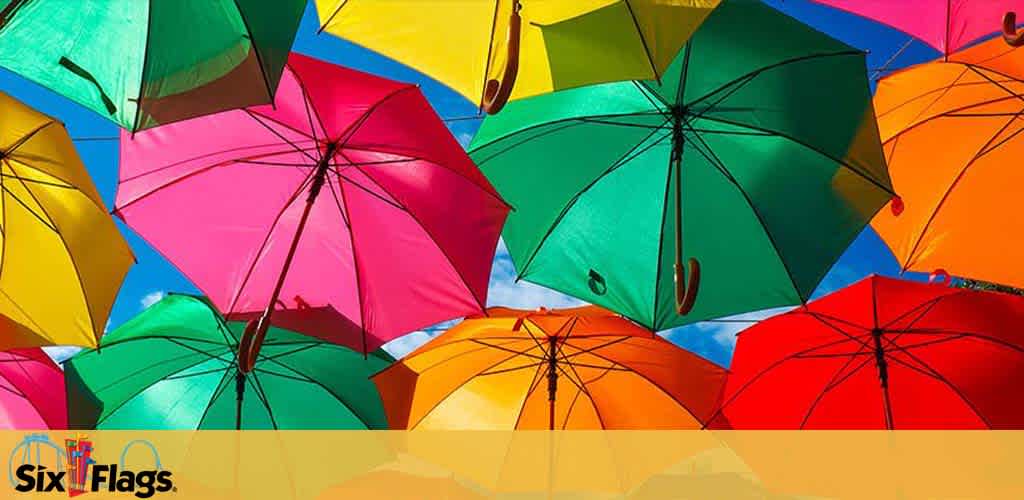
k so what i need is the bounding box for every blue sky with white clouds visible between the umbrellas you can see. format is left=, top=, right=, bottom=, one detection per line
left=0, top=0, right=937, bottom=365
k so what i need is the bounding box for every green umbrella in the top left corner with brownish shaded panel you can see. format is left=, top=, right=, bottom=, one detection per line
left=0, top=0, right=305, bottom=130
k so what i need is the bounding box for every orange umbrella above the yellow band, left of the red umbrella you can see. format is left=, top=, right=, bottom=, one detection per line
left=374, top=306, right=725, bottom=430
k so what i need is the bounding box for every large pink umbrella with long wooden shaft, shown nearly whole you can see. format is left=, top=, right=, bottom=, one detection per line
left=115, top=53, right=509, bottom=371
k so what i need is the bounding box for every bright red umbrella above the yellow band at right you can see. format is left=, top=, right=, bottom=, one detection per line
left=709, top=277, right=1024, bottom=429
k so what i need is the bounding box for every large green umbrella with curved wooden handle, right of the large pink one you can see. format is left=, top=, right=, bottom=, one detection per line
left=470, top=0, right=892, bottom=330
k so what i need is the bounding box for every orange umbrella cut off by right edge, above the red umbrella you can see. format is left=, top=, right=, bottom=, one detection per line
left=872, top=38, right=1024, bottom=287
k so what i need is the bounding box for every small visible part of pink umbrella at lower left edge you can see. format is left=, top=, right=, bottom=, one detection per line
left=0, top=348, right=68, bottom=430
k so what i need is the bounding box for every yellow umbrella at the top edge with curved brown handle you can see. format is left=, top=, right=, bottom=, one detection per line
left=316, top=0, right=721, bottom=113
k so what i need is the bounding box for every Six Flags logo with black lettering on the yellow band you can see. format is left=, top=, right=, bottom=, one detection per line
left=8, top=434, right=175, bottom=498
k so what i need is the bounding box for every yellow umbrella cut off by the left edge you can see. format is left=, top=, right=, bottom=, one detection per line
left=0, top=92, right=135, bottom=348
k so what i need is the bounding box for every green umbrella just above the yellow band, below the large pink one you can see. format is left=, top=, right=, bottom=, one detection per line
left=65, top=294, right=394, bottom=429
